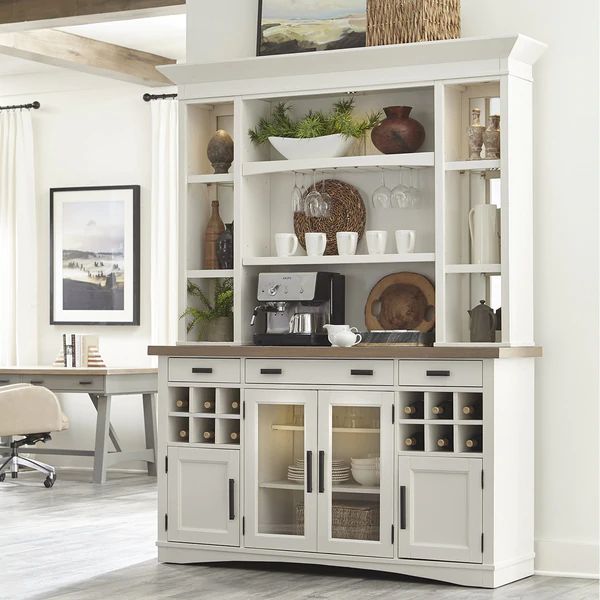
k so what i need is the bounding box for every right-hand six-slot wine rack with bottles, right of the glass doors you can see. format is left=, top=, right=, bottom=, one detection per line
left=398, top=391, right=484, bottom=455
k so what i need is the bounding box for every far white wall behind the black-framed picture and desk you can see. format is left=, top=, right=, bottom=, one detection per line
left=0, top=69, right=175, bottom=468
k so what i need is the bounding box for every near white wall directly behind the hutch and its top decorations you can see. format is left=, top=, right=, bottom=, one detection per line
left=187, top=0, right=600, bottom=575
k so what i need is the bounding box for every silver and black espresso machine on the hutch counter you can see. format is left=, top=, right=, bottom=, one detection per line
left=250, top=272, right=346, bottom=346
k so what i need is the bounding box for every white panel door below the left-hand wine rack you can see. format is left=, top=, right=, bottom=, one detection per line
left=167, top=447, right=240, bottom=546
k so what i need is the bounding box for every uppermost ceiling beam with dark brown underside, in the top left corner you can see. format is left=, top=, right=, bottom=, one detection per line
left=0, top=0, right=186, bottom=32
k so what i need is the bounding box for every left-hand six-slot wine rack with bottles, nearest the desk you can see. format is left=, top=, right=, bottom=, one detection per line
left=167, top=387, right=242, bottom=447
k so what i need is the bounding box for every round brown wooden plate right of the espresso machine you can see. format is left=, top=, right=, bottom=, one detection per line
left=365, top=273, right=435, bottom=332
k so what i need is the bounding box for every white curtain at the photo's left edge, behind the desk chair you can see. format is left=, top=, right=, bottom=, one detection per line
left=0, top=109, right=38, bottom=366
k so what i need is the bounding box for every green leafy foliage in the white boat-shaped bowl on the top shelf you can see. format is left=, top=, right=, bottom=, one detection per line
left=248, top=98, right=383, bottom=144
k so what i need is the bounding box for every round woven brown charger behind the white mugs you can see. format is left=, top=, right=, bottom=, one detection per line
left=294, top=179, right=367, bottom=255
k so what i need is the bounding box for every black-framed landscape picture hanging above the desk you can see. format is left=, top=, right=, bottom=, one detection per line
left=50, top=185, right=140, bottom=325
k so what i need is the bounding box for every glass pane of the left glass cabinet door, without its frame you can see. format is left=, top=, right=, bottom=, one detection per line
left=258, top=404, right=306, bottom=536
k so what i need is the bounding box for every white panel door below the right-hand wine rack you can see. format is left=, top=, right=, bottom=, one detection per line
left=398, top=456, right=483, bottom=563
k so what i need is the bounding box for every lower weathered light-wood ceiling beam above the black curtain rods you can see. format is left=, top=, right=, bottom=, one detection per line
left=0, top=29, right=176, bottom=86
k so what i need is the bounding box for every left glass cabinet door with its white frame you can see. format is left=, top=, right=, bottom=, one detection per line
left=244, top=389, right=317, bottom=551
